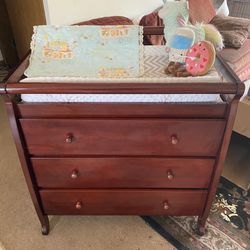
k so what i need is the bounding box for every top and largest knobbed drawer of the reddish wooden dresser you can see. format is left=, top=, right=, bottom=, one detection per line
left=20, top=119, right=225, bottom=156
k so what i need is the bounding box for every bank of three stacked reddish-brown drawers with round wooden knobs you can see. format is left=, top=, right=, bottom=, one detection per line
left=23, top=117, right=225, bottom=215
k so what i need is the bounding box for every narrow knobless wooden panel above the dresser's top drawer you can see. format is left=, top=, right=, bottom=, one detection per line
left=17, top=103, right=228, bottom=118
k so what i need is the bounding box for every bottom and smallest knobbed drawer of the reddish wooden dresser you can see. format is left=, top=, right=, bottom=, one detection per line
left=40, top=189, right=207, bottom=216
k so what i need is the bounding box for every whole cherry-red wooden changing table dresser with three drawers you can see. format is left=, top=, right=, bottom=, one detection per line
left=0, top=28, right=244, bottom=235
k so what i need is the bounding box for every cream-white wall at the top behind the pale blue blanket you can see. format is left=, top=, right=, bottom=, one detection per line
left=43, top=0, right=163, bottom=25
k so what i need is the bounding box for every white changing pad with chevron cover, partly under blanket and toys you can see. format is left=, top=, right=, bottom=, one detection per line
left=21, top=46, right=222, bottom=102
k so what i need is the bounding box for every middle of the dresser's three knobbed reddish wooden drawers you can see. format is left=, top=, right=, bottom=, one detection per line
left=31, top=157, right=214, bottom=188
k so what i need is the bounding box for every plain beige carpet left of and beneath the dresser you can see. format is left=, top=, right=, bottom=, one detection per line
left=0, top=98, right=174, bottom=250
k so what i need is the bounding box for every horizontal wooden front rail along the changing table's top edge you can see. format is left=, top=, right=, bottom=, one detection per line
left=3, top=82, right=237, bottom=94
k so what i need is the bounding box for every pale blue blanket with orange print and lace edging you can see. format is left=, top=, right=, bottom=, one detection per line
left=25, top=25, right=143, bottom=78
